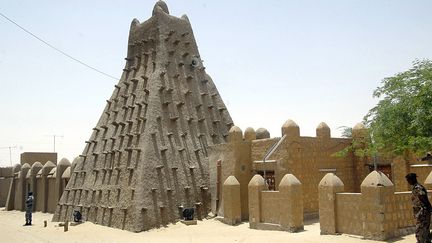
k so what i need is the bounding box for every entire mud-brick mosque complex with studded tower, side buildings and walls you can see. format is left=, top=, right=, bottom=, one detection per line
left=0, top=1, right=432, bottom=240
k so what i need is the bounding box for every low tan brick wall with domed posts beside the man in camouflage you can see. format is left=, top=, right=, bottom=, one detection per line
left=319, top=171, right=432, bottom=240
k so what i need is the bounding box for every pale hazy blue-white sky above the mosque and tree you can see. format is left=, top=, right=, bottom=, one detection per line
left=0, top=0, right=432, bottom=166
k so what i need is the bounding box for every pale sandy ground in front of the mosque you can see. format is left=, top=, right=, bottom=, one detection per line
left=0, top=208, right=416, bottom=243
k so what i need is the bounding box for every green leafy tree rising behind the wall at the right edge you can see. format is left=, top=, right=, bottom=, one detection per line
left=364, top=60, right=432, bottom=155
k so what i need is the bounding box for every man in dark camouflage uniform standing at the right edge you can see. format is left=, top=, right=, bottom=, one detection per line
left=405, top=173, right=432, bottom=243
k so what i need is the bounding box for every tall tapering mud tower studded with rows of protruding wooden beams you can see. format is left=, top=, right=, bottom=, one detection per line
left=53, top=1, right=233, bottom=232
